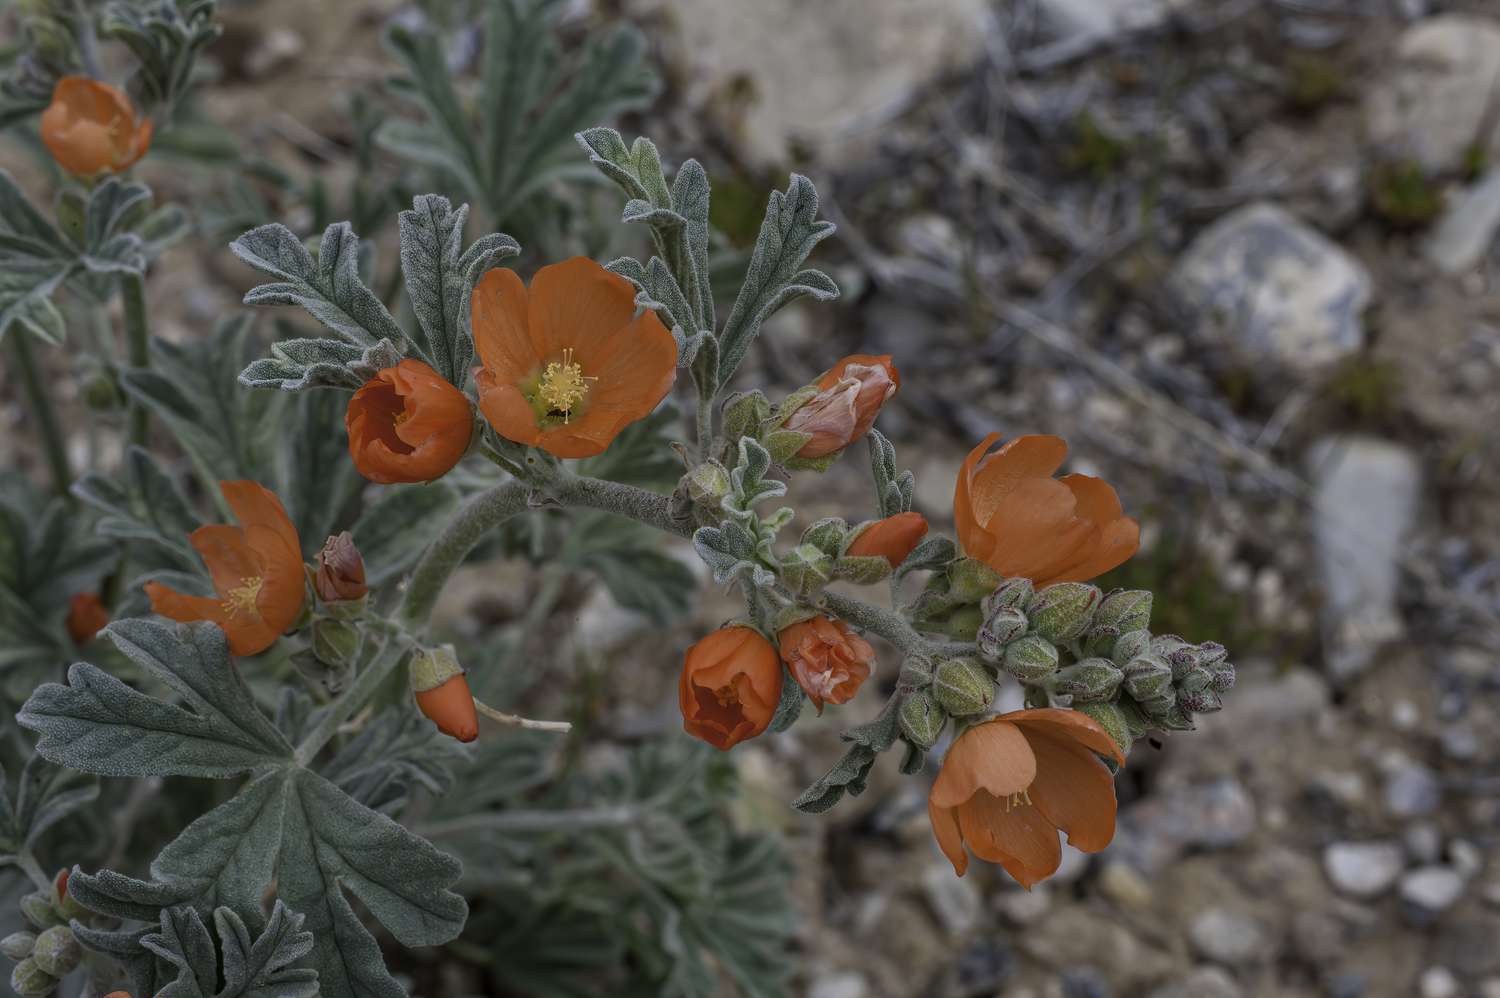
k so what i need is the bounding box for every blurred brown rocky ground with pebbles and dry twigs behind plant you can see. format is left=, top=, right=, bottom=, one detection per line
left=8, top=0, right=1500, bottom=998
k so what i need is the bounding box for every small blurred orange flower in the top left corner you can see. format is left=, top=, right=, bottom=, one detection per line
left=42, top=77, right=152, bottom=177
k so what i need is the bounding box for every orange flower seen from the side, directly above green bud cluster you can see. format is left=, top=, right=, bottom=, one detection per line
left=953, top=434, right=1140, bottom=588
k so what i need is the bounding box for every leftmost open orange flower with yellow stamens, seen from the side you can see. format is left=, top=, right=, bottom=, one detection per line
left=146, top=482, right=306, bottom=654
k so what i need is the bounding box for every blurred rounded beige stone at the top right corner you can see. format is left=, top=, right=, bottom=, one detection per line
left=1364, top=15, right=1500, bottom=171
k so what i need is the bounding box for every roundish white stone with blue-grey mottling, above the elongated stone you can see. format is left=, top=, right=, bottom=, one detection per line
left=1170, top=203, right=1371, bottom=372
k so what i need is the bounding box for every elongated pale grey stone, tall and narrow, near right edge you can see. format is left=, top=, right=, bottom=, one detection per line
left=1308, top=437, right=1422, bottom=678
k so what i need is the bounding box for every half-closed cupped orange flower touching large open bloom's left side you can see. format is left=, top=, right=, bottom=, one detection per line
left=344, top=360, right=474, bottom=485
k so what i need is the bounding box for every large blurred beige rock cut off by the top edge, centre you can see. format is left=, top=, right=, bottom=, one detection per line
left=632, top=0, right=992, bottom=165
